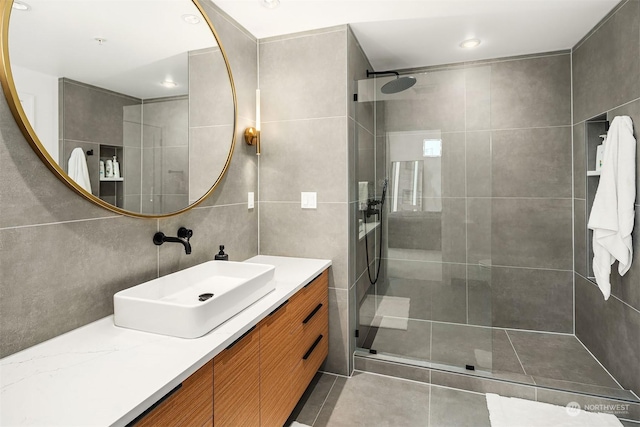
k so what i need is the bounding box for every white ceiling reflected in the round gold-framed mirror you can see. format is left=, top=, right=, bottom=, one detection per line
left=9, top=0, right=216, bottom=99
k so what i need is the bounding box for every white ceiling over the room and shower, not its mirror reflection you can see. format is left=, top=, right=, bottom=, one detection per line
left=213, top=0, right=619, bottom=71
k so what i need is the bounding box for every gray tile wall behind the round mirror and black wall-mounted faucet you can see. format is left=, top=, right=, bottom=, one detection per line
left=0, top=3, right=255, bottom=357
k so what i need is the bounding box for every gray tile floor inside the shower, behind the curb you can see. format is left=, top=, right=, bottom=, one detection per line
left=366, top=319, right=621, bottom=396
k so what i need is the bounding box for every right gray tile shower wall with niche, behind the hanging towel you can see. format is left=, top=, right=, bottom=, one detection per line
left=573, top=0, right=640, bottom=393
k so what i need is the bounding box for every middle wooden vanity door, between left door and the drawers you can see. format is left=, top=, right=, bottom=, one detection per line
left=213, top=326, right=260, bottom=427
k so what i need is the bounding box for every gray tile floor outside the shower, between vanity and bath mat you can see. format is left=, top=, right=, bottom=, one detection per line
left=288, top=372, right=490, bottom=427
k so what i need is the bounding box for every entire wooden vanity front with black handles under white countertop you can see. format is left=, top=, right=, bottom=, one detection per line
left=136, top=270, right=329, bottom=427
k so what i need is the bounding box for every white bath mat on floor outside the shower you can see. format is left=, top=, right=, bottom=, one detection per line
left=487, top=393, right=623, bottom=427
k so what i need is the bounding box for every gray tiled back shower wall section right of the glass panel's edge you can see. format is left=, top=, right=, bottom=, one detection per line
left=480, top=53, right=574, bottom=333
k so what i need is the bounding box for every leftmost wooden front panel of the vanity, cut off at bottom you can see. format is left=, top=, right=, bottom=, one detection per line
left=134, top=361, right=213, bottom=427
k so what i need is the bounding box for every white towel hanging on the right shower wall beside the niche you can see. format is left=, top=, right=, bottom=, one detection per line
left=588, top=116, right=636, bottom=300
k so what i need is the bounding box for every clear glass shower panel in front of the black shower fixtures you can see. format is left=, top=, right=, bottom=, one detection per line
left=356, top=69, right=492, bottom=371
